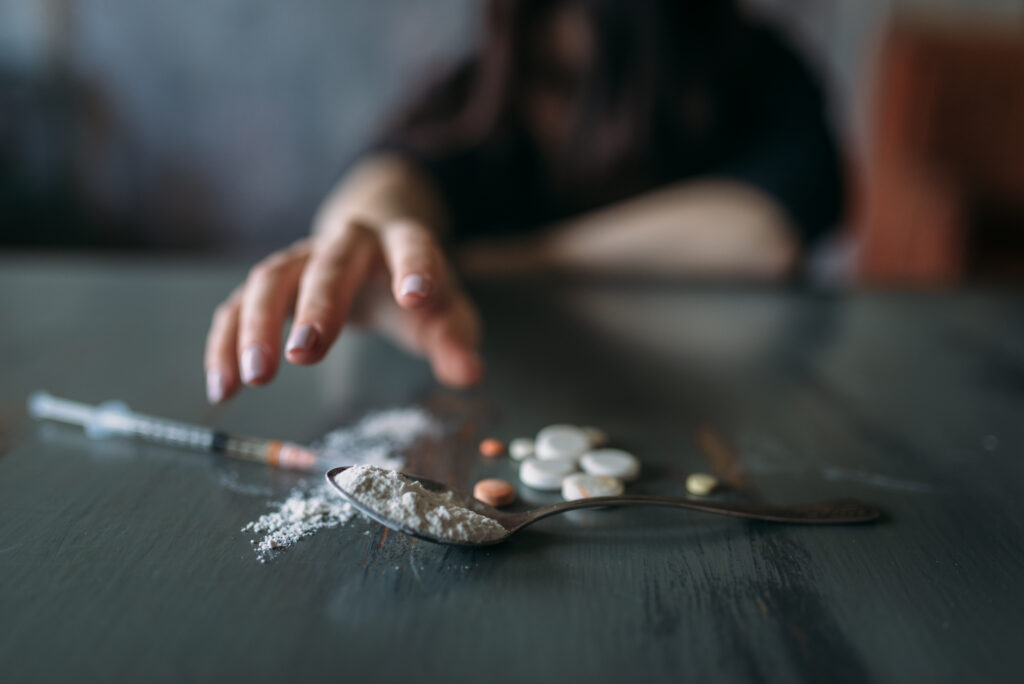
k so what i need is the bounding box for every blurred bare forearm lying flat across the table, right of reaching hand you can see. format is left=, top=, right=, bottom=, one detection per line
left=462, top=180, right=799, bottom=279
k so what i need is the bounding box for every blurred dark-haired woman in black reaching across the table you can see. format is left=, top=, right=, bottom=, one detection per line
left=199, top=0, right=842, bottom=402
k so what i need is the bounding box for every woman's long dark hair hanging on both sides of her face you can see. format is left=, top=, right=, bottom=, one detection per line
left=385, top=0, right=746, bottom=200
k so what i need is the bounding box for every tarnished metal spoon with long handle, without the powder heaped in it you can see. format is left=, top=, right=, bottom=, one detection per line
left=327, top=466, right=881, bottom=546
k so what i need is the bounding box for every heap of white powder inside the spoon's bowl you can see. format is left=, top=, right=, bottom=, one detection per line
left=334, top=466, right=508, bottom=544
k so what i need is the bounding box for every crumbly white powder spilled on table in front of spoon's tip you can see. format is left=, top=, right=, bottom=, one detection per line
left=242, top=484, right=355, bottom=563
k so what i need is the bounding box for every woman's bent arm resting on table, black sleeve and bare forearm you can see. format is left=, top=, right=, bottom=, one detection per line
left=461, top=30, right=843, bottom=279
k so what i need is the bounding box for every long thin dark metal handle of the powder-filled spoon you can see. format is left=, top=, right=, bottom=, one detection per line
left=519, top=495, right=881, bottom=527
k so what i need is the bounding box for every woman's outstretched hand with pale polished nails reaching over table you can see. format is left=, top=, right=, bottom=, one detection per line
left=205, top=220, right=483, bottom=403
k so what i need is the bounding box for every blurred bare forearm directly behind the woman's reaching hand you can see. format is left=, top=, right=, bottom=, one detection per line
left=313, top=155, right=446, bottom=234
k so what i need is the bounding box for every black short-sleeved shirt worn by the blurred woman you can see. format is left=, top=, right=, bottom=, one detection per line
left=372, top=24, right=843, bottom=245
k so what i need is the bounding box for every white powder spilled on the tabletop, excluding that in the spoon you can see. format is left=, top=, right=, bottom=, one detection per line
left=246, top=409, right=441, bottom=563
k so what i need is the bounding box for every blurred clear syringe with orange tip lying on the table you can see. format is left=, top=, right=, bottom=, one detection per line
left=29, top=392, right=316, bottom=470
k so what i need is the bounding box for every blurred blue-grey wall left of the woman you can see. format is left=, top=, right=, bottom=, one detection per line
left=0, top=0, right=476, bottom=252
